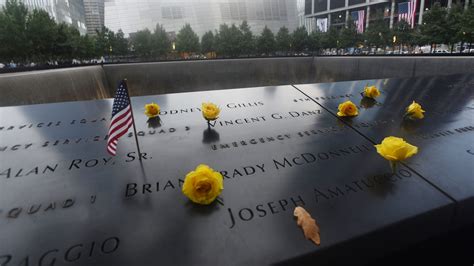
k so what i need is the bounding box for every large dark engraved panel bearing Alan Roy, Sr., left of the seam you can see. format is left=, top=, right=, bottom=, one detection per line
left=0, top=82, right=460, bottom=265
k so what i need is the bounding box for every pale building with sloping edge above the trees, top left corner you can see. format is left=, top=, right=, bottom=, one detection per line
left=0, top=0, right=87, bottom=34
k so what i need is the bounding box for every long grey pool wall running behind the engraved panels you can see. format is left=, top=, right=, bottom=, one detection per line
left=0, top=56, right=474, bottom=106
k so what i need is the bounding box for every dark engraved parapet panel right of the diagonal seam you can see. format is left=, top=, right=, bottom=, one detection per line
left=295, top=75, right=474, bottom=227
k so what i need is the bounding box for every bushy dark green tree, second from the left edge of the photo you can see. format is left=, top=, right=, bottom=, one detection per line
left=26, top=9, right=56, bottom=62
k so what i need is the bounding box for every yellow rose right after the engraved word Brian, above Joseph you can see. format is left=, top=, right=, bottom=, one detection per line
left=182, top=164, right=224, bottom=205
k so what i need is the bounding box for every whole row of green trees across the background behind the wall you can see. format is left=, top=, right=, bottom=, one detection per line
left=0, top=0, right=474, bottom=63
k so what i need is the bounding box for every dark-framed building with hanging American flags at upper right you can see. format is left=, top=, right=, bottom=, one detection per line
left=304, top=0, right=469, bottom=32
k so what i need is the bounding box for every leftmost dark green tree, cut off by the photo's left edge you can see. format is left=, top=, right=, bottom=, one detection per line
left=0, top=0, right=30, bottom=61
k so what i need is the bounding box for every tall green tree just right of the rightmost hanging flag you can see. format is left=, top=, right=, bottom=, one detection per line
left=420, top=2, right=448, bottom=50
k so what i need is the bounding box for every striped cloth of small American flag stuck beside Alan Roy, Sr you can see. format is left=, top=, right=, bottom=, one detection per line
left=107, top=80, right=133, bottom=156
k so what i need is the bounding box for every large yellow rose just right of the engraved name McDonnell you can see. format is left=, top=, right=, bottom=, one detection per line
left=375, top=137, right=418, bottom=162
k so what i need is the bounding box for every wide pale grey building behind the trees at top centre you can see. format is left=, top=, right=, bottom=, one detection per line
left=105, top=0, right=298, bottom=36
